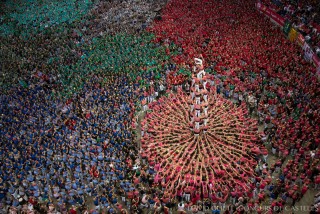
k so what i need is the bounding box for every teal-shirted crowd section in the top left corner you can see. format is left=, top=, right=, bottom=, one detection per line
left=0, top=0, right=94, bottom=38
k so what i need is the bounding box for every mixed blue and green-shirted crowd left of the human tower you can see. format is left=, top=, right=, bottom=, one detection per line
left=1, top=1, right=169, bottom=213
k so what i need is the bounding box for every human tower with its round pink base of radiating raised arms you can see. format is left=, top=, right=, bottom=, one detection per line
left=141, top=58, right=261, bottom=194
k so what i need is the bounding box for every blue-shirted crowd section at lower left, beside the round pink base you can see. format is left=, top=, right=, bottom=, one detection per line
left=1, top=73, right=146, bottom=212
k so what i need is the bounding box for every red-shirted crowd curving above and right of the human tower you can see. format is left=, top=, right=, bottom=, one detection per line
left=146, top=1, right=320, bottom=212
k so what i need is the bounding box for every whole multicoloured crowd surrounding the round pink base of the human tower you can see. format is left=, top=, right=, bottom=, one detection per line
left=0, top=0, right=320, bottom=213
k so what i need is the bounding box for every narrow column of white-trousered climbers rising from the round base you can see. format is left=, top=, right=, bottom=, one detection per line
left=190, top=58, right=209, bottom=136
